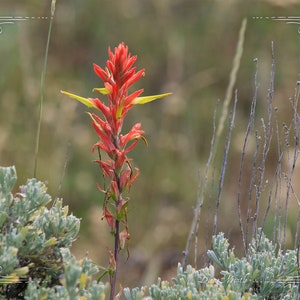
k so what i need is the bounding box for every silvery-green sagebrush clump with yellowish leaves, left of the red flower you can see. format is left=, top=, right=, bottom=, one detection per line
left=0, top=167, right=107, bottom=299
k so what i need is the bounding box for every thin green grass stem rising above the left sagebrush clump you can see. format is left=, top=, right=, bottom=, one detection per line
left=33, top=0, right=56, bottom=177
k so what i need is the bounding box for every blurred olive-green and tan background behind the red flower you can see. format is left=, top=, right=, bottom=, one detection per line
left=0, top=0, right=300, bottom=287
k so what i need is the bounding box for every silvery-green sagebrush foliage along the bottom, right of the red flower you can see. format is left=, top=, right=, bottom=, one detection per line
left=124, top=230, right=298, bottom=300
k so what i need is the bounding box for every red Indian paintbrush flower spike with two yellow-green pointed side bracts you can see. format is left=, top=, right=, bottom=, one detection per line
left=62, top=43, right=170, bottom=300
